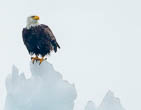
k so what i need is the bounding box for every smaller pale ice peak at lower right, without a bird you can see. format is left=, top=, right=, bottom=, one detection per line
left=85, top=90, right=125, bottom=110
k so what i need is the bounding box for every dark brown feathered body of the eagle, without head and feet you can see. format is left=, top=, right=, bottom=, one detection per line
left=22, top=24, right=60, bottom=57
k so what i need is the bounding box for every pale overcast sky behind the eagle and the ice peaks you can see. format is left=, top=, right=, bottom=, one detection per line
left=0, top=0, right=141, bottom=110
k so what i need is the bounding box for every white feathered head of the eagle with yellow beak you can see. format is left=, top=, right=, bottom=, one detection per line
left=26, top=15, right=40, bottom=29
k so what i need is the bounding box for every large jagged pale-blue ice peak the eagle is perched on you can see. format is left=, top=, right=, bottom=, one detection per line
left=4, top=61, right=77, bottom=110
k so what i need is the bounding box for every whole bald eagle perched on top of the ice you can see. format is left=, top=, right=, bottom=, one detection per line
left=22, top=16, right=60, bottom=64
